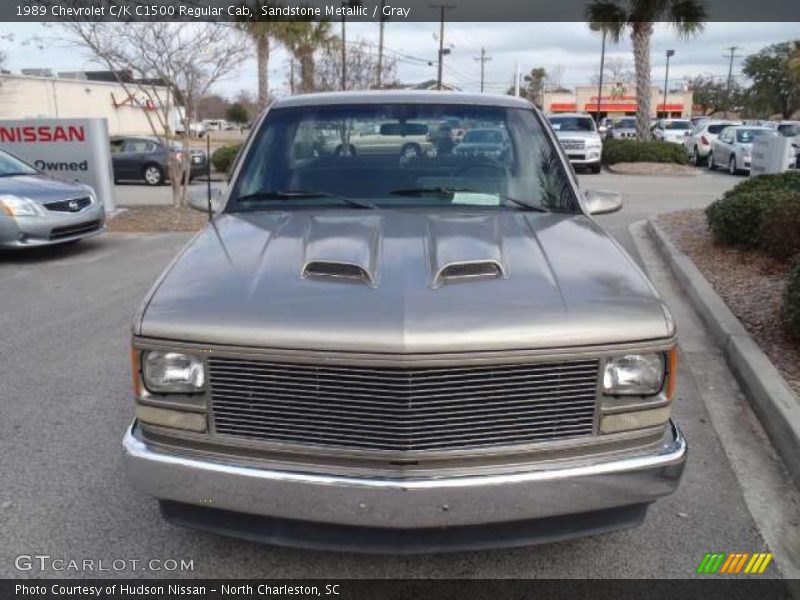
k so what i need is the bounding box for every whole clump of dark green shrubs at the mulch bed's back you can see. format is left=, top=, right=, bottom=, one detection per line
left=706, top=171, right=800, bottom=260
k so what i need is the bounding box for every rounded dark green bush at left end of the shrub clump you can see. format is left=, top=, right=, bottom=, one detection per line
left=706, top=193, right=769, bottom=248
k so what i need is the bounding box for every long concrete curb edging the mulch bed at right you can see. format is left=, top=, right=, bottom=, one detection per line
left=647, top=219, right=800, bottom=485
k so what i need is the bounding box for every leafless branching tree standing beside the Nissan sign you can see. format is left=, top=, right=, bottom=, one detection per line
left=63, top=21, right=247, bottom=207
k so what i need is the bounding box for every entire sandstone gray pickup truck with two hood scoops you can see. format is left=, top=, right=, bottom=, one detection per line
left=124, top=92, right=687, bottom=552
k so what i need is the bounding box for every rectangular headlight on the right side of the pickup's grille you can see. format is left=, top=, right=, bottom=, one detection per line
left=603, top=353, right=666, bottom=396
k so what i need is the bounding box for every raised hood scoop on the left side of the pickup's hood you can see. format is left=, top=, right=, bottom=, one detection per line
left=301, top=216, right=380, bottom=287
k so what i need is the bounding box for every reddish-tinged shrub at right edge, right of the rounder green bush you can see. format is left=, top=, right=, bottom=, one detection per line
left=759, top=191, right=800, bottom=260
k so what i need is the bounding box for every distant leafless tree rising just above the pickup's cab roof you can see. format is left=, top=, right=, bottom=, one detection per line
left=314, top=38, right=397, bottom=91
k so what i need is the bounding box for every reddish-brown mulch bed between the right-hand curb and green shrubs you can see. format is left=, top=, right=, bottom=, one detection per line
left=658, top=210, right=800, bottom=396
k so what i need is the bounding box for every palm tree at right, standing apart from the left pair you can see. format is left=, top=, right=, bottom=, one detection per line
left=586, top=0, right=706, bottom=140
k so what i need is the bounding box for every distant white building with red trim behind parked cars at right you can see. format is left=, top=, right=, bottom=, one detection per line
left=542, top=83, right=693, bottom=118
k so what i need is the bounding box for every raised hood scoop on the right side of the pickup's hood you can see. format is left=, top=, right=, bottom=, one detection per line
left=428, top=215, right=507, bottom=288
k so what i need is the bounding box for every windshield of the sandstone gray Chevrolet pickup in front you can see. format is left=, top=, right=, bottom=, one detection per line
left=226, top=103, right=580, bottom=212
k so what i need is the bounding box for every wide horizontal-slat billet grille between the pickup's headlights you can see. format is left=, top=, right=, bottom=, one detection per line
left=209, top=358, right=598, bottom=451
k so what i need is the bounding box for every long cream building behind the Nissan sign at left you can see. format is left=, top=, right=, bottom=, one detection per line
left=0, top=69, right=180, bottom=135
